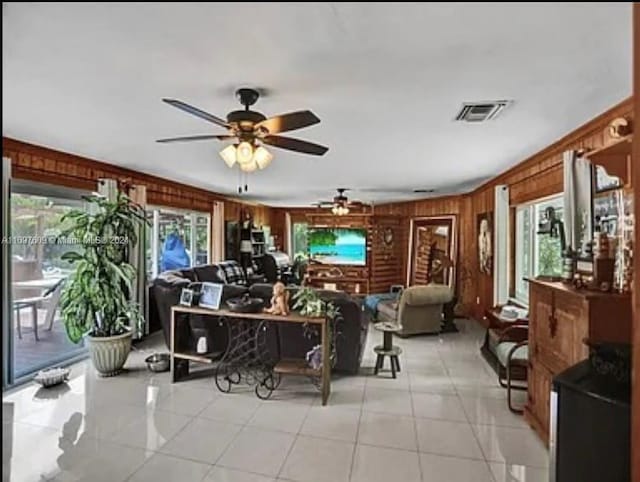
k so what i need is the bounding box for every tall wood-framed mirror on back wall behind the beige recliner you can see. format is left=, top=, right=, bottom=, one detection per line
left=407, top=216, right=457, bottom=287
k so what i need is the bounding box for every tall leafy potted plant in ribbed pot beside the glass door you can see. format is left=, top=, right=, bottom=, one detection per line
left=60, top=193, right=146, bottom=376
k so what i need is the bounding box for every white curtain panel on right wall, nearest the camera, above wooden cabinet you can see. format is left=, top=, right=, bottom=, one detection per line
left=563, top=151, right=593, bottom=255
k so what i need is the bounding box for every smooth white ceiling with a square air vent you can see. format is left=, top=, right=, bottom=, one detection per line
left=2, top=3, right=632, bottom=205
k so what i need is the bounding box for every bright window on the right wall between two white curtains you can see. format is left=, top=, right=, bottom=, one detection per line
left=515, top=196, right=563, bottom=304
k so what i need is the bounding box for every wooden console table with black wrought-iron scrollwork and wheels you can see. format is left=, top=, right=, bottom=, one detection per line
left=170, top=305, right=331, bottom=405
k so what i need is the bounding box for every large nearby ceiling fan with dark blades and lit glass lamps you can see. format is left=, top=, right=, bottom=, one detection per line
left=157, top=88, right=329, bottom=177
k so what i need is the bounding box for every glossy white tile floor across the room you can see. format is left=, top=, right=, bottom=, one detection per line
left=2, top=321, right=548, bottom=482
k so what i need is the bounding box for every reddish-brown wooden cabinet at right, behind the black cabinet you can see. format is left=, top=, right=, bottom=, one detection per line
left=525, top=280, right=631, bottom=443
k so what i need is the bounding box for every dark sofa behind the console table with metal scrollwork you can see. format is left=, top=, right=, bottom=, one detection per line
left=149, top=265, right=370, bottom=374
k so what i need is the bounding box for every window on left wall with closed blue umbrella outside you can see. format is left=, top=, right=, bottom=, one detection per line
left=146, top=208, right=211, bottom=278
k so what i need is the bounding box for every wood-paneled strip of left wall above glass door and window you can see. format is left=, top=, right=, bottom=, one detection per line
left=2, top=137, right=271, bottom=224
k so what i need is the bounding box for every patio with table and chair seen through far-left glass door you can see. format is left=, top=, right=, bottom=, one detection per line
left=10, top=193, right=84, bottom=377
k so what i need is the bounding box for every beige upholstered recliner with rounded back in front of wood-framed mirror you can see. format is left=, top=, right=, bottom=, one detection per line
left=379, top=284, right=453, bottom=336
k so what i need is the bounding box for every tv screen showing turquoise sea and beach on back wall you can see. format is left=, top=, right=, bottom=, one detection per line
left=307, top=228, right=367, bottom=266
